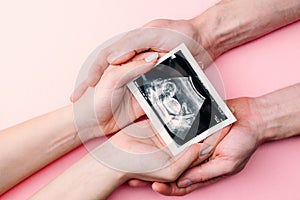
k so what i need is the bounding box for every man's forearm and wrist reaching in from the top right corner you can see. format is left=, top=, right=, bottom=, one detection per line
left=191, top=0, right=300, bottom=59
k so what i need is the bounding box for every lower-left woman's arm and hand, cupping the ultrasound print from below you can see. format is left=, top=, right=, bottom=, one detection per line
left=30, top=120, right=209, bottom=200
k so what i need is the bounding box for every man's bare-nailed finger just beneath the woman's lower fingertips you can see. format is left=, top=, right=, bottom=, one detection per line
left=177, top=158, right=234, bottom=187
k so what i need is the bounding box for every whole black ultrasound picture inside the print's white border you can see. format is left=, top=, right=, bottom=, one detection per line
left=133, top=50, right=227, bottom=146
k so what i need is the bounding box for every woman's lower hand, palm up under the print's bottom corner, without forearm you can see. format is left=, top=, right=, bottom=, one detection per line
left=92, top=120, right=213, bottom=182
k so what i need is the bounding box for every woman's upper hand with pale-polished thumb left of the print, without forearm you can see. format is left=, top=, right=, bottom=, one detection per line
left=73, top=52, right=158, bottom=141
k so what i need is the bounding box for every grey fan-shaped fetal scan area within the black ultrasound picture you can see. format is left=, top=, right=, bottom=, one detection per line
left=144, top=77, right=205, bottom=140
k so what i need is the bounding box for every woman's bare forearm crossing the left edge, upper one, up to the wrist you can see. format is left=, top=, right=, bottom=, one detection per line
left=0, top=105, right=81, bottom=194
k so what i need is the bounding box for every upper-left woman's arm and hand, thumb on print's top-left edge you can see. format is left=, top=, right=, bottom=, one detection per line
left=0, top=53, right=158, bottom=194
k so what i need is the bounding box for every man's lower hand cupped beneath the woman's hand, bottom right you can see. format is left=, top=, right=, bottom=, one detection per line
left=152, top=98, right=264, bottom=195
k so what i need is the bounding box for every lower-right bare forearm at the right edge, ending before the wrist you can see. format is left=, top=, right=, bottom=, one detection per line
left=255, top=83, right=300, bottom=142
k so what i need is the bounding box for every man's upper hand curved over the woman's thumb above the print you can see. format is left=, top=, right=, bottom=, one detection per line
left=71, top=19, right=212, bottom=102
